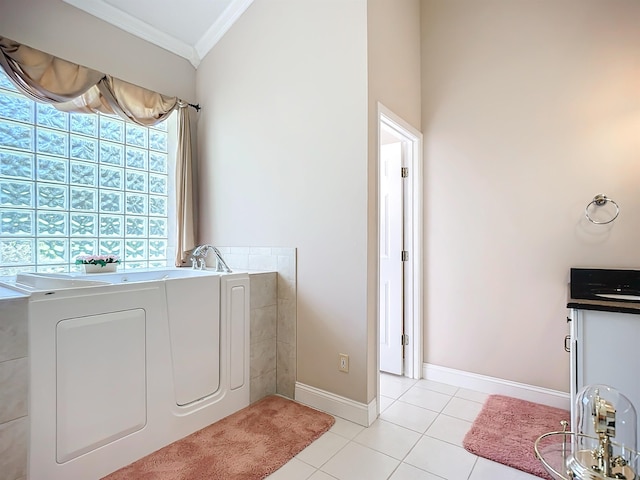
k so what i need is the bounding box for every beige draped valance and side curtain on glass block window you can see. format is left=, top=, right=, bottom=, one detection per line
left=0, top=36, right=195, bottom=266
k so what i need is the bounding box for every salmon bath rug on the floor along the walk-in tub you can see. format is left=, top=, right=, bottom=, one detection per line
left=103, top=395, right=335, bottom=480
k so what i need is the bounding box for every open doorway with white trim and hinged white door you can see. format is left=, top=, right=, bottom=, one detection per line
left=378, top=104, right=422, bottom=391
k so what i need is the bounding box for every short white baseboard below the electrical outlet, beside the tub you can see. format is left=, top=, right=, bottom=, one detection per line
left=295, top=382, right=378, bottom=427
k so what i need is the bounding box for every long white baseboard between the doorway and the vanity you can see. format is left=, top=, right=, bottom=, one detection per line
left=422, top=363, right=571, bottom=410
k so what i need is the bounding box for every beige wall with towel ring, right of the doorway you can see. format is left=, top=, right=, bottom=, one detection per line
left=422, top=0, right=640, bottom=391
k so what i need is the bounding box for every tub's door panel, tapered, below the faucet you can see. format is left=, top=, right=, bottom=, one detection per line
left=165, top=275, right=220, bottom=406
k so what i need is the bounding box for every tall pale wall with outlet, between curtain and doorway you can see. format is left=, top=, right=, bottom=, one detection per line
left=197, top=0, right=367, bottom=401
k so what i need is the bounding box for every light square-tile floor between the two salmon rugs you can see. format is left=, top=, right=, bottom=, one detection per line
left=267, top=374, right=538, bottom=480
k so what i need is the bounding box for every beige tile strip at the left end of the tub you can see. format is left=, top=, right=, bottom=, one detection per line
left=0, top=297, right=29, bottom=480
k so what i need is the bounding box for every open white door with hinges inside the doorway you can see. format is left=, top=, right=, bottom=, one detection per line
left=379, top=142, right=404, bottom=375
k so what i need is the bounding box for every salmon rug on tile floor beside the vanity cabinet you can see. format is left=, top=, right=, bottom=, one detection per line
left=462, top=395, right=571, bottom=480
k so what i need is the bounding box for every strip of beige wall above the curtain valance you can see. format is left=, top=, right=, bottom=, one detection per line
left=0, top=0, right=195, bottom=101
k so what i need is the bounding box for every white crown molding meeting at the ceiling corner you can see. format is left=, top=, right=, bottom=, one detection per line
left=63, top=0, right=253, bottom=68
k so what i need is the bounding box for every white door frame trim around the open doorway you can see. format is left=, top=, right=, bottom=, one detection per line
left=376, top=102, right=424, bottom=384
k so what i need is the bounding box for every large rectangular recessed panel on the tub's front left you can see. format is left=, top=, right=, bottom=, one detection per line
left=56, top=309, right=147, bottom=463
